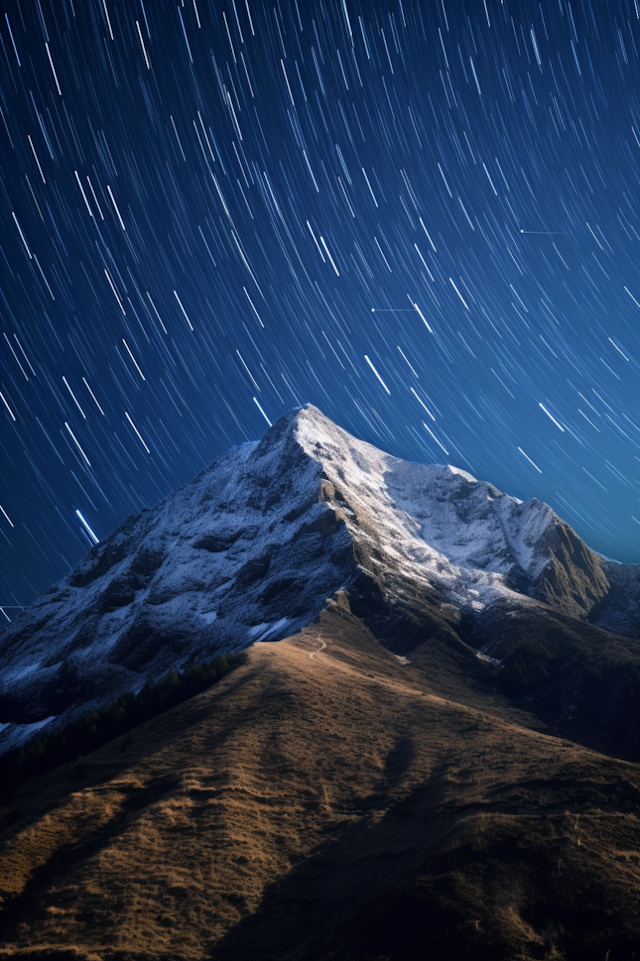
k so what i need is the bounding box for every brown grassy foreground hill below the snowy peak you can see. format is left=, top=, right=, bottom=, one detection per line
left=0, top=593, right=640, bottom=961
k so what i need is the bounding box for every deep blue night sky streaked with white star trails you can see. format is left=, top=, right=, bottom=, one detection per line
left=0, top=0, right=640, bottom=616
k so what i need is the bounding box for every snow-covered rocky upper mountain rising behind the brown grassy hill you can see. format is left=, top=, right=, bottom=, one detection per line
left=0, top=405, right=640, bottom=750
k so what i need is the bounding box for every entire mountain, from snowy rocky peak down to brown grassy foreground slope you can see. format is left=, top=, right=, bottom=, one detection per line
left=0, top=406, right=640, bottom=961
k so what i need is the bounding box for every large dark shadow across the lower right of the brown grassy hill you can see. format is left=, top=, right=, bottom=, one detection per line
left=210, top=763, right=640, bottom=961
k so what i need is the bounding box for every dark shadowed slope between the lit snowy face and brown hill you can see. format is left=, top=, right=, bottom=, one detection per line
left=348, top=569, right=640, bottom=760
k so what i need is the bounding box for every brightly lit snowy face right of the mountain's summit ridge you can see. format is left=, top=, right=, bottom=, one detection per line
left=296, top=408, right=607, bottom=614
